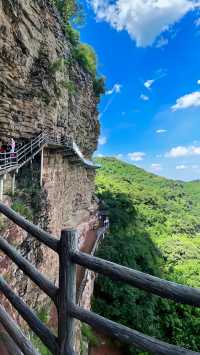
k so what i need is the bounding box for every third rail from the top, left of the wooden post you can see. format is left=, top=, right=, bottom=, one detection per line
left=0, top=276, right=58, bottom=354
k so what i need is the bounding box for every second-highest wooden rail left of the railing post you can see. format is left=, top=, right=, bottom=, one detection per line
left=0, top=236, right=58, bottom=303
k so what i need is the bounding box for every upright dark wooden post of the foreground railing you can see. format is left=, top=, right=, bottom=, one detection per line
left=57, top=230, right=78, bottom=355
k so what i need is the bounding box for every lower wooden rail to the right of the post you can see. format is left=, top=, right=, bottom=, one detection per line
left=70, top=304, right=200, bottom=355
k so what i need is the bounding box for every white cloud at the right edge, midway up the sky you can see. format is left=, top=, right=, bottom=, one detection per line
left=171, top=91, right=200, bottom=111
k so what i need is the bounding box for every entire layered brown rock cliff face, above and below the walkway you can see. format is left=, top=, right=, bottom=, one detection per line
left=0, top=0, right=99, bottom=349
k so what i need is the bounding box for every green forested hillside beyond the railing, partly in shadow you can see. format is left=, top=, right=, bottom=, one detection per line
left=93, top=158, right=200, bottom=354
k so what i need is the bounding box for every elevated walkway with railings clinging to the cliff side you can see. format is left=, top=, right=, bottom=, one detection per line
left=0, top=132, right=98, bottom=176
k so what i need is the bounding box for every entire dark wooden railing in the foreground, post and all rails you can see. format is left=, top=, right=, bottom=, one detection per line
left=0, top=203, right=200, bottom=355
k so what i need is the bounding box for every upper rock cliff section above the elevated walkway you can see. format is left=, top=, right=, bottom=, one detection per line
left=0, top=0, right=99, bottom=156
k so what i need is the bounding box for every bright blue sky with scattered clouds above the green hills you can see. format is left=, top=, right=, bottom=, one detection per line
left=81, top=0, right=200, bottom=180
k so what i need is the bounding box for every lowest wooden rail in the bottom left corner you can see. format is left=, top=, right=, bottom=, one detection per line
left=0, top=305, right=39, bottom=355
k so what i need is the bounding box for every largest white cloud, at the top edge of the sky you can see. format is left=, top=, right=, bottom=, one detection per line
left=90, top=0, right=199, bottom=47
